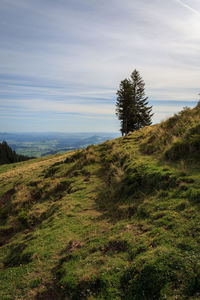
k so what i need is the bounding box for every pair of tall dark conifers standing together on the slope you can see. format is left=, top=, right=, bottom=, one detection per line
left=116, top=70, right=153, bottom=135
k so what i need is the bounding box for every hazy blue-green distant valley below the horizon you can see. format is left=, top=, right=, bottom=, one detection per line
left=0, top=132, right=119, bottom=157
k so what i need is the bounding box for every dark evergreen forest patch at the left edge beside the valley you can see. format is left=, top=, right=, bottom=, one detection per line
left=0, top=141, right=30, bottom=165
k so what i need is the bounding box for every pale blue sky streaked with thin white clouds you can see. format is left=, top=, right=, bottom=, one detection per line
left=0, top=0, right=200, bottom=132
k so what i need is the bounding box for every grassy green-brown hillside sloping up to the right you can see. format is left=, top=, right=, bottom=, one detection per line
left=0, top=104, right=200, bottom=300
